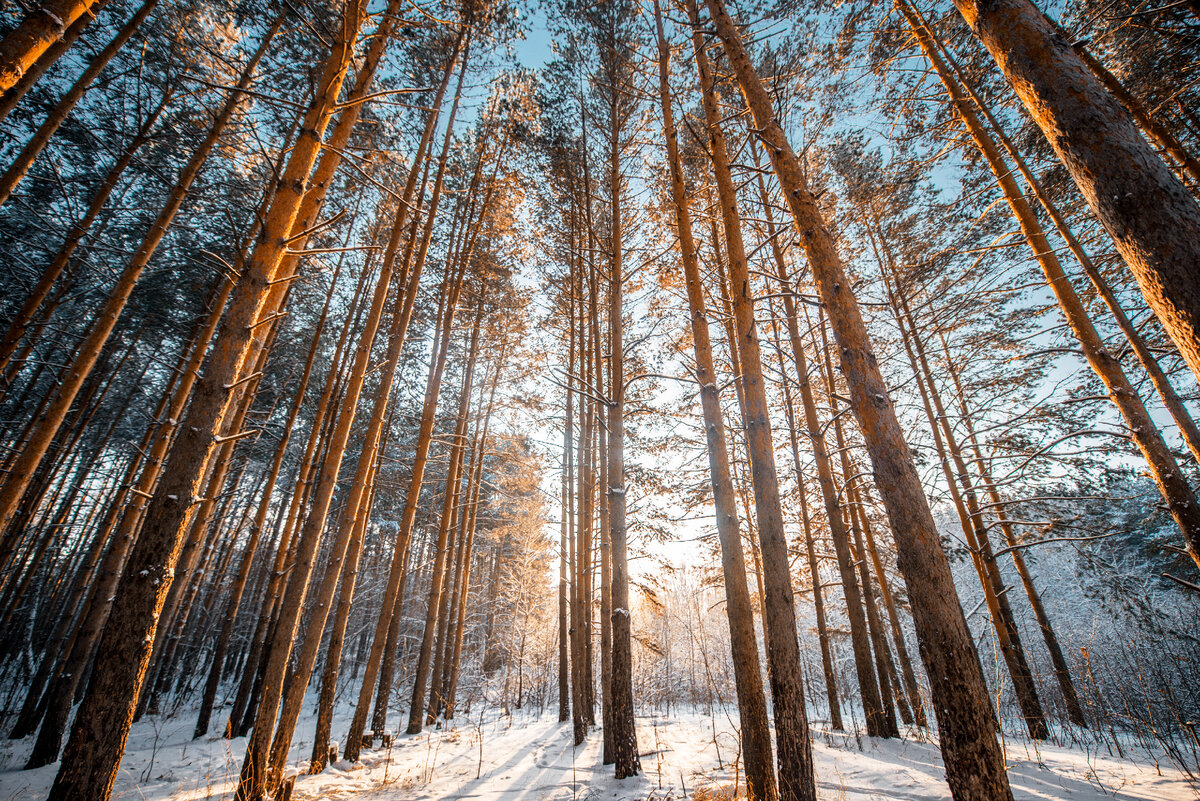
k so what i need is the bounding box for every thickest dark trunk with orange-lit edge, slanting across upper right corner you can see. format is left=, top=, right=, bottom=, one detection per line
left=954, top=0, right=1200, bottom=402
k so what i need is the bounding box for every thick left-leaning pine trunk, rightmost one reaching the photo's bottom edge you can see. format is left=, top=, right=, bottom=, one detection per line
left=706, top=0, right=1012, bottom=801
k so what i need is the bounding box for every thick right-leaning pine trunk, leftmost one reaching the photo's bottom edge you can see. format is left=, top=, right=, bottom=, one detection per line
left=50, top=0, right=365, bottom=801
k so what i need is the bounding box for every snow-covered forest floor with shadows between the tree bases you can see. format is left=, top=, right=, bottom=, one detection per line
left=0, top=705, right=1196, bottom=801
